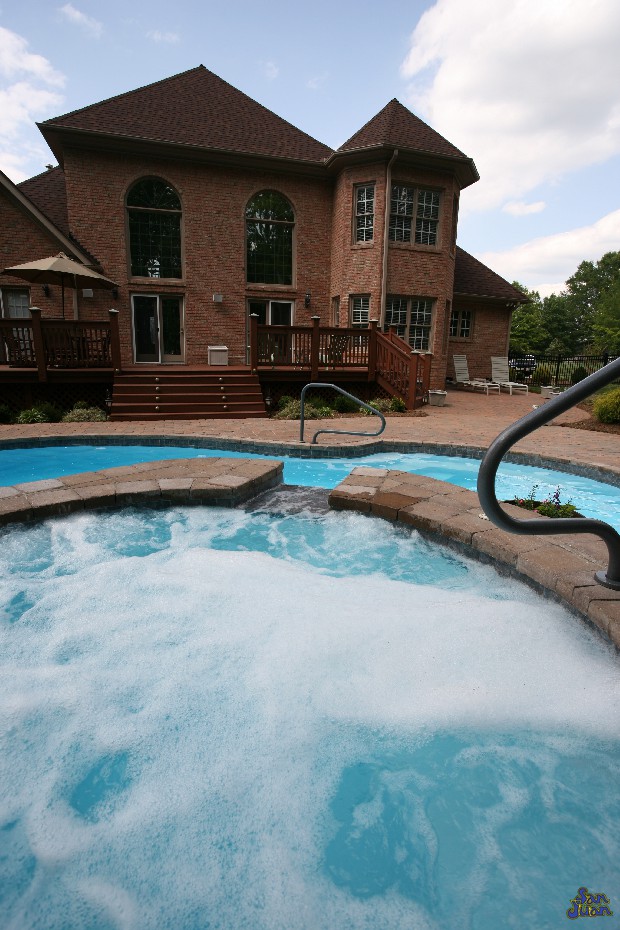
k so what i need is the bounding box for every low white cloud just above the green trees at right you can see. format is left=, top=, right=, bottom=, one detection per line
left=476, top=210, right=620, bottom=296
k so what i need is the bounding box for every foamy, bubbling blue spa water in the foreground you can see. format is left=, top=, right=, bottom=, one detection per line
left=0, top=508, right=620, bottom=930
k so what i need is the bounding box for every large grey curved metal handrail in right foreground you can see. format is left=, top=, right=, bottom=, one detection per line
left=478, top=359, right=620, bottom=591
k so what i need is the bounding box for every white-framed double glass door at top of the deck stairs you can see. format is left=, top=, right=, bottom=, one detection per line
left=132, top=294, right=185, bottom=364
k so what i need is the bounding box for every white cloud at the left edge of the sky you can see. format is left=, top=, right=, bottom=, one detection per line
left=0, top=27, right=65, bottom=182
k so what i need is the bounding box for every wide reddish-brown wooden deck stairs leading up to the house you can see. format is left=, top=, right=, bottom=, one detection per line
left=110, top=366, right=267, bottom=421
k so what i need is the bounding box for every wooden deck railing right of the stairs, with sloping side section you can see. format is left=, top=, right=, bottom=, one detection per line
left=250, top=316, right=432, bottom=409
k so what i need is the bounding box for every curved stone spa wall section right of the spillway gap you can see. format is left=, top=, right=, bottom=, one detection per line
left=329, top=466, right=620, bottom=648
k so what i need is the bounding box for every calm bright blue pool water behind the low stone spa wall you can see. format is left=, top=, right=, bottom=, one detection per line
left=0, top=446, right=620, bottom=529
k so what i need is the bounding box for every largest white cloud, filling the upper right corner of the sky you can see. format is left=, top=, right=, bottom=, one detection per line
left=401, top=0, right=620, bottom=210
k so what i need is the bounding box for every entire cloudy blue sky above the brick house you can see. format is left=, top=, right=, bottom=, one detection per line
left=0, top=0, right=620, bottom=296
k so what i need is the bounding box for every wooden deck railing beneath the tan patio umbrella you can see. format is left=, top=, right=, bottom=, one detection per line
left=0, top=307, right=121, bottom=381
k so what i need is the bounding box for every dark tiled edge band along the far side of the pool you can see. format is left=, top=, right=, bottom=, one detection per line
left=0, top=433, right=620, bottom=487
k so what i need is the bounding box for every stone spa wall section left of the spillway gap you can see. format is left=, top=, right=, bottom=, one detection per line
left=0, top=458, right=284, bottom=526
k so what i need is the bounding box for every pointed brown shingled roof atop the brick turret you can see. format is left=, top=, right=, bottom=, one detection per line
left=338, top=97, right=467, bottom=158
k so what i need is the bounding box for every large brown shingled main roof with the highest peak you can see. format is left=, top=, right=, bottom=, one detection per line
left=39, top=65, right=332, bottom=163
